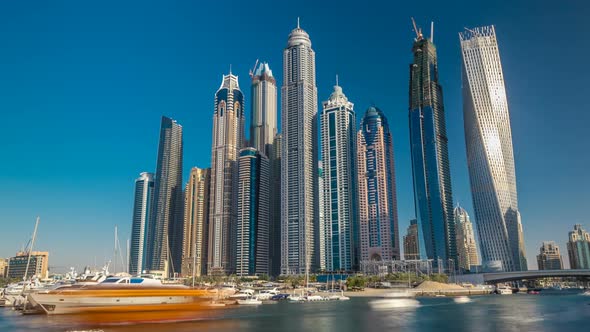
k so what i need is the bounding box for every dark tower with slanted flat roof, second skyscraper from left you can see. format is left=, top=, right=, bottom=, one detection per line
left=148, top=116, right=184, bottom=274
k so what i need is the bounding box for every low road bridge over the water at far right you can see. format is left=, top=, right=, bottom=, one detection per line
left=456, top=269, right=590, bottom=284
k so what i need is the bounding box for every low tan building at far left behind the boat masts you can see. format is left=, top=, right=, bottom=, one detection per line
left=7, top=251, right=49, bottom=279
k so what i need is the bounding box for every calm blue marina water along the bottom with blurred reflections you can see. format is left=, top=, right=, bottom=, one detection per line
left=0, top=292, right=590, bottom=332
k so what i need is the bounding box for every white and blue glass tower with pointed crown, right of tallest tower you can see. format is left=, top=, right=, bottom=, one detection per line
left=319, top=82, right=359, bottom=271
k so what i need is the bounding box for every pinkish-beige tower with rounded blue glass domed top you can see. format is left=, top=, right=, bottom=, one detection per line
left=357, top=106, right=400, bottom=261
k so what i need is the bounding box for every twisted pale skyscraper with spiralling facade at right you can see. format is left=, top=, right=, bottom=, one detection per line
left=459, top=26, right=527, bottom=271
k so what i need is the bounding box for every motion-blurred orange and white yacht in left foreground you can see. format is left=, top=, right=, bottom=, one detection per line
left=28, top=277, right=219, bottom=322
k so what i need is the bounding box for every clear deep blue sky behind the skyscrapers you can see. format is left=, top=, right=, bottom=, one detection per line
left=0, top=0, right=590, bottom=271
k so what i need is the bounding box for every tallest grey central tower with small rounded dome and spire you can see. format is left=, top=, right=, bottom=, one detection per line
left=281, top=20, right=318, bottom=274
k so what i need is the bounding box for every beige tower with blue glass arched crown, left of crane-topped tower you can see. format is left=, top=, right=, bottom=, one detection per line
left=207, top=73, right=244, bottom=274
